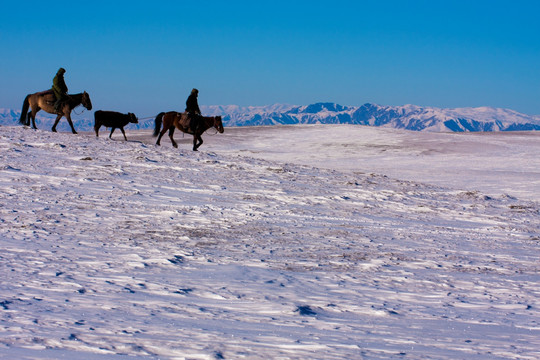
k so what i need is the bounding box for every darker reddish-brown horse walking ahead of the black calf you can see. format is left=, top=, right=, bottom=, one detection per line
left=154, top=111, right=224, bottom=151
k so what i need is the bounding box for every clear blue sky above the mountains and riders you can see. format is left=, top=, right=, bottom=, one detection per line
left=0, top=0, right=540, bottom=117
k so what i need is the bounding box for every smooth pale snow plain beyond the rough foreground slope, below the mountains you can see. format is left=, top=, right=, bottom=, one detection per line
left=130, top=124, right=540, bottom=201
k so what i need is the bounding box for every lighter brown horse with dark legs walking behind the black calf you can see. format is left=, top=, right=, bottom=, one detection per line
left=19, top=90, right=92, bottom=134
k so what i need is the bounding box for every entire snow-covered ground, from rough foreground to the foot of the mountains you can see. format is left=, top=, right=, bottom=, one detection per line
left=0, top=125, right=540, bottom=359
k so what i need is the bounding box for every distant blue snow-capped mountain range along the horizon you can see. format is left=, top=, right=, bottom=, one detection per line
left=0, top=103, right=540, bottom=132
